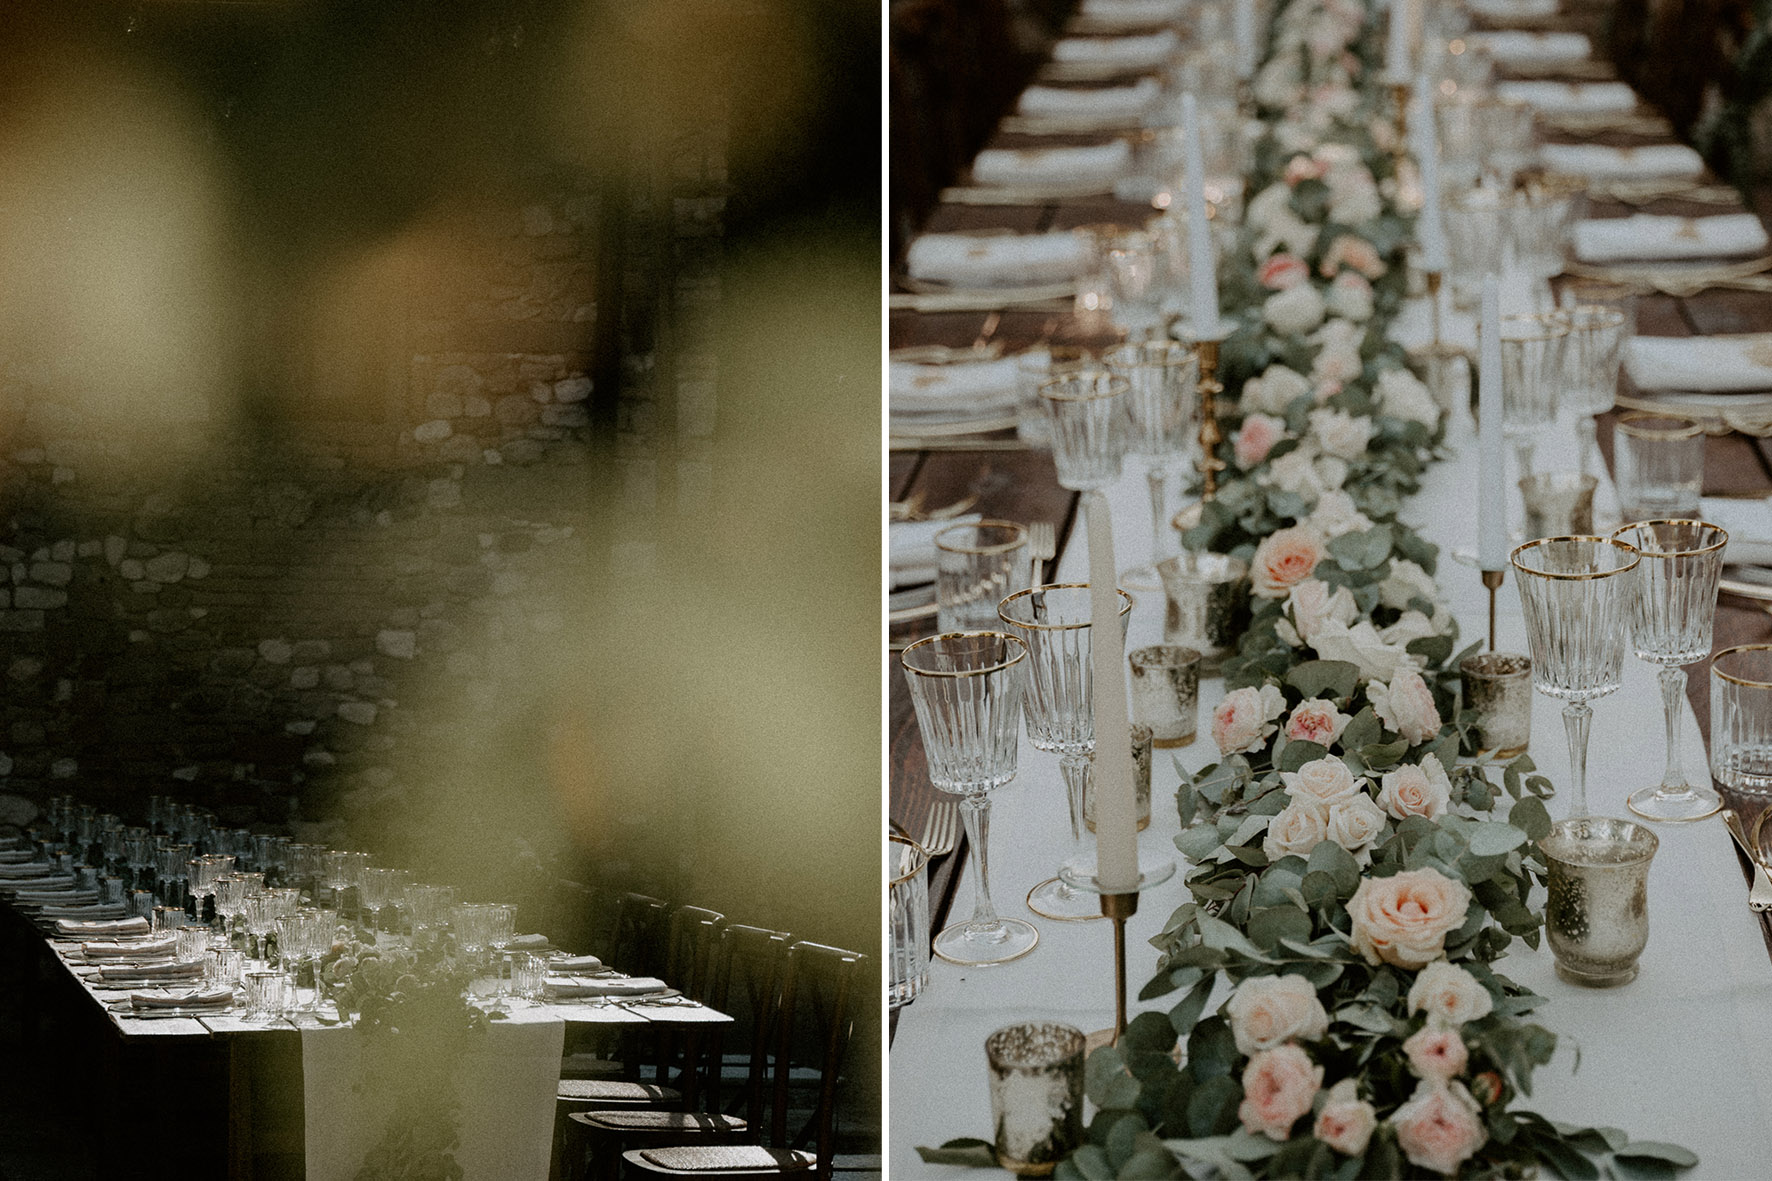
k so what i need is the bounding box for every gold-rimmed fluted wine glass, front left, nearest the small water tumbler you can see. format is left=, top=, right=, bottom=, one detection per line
left=900, top=631, right=1040, bottom=965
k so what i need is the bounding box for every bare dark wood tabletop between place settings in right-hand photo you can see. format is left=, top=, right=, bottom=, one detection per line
left=890, top=12, right=1772, bottom=952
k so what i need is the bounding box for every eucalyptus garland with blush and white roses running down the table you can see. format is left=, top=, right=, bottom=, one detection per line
left=925, top=0, right=1698, bottom=1179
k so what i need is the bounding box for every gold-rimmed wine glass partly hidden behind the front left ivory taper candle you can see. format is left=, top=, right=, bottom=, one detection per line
left=998, top=583, right=1132, bottom=922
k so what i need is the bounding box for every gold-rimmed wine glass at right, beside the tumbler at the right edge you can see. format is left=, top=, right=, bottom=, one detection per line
left=1613, top=521, right=1729, bottom=821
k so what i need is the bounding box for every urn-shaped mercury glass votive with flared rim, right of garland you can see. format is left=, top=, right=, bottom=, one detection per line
left=1538, top=816, right=1660, bottom=988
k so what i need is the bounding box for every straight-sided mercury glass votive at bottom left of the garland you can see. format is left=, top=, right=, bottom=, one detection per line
left=985, top=1021, right=1084, bottom=1177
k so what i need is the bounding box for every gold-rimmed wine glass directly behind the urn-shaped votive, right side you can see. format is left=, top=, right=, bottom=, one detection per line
left=1512, top=537, right=1639, bottom=816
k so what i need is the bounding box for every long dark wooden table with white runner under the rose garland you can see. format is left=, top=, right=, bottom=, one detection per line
left=888, top=2, right=1772, bottom=1177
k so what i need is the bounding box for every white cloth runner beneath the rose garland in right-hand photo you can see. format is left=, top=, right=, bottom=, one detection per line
left=888, top=407, right=1772, bottom=1177
